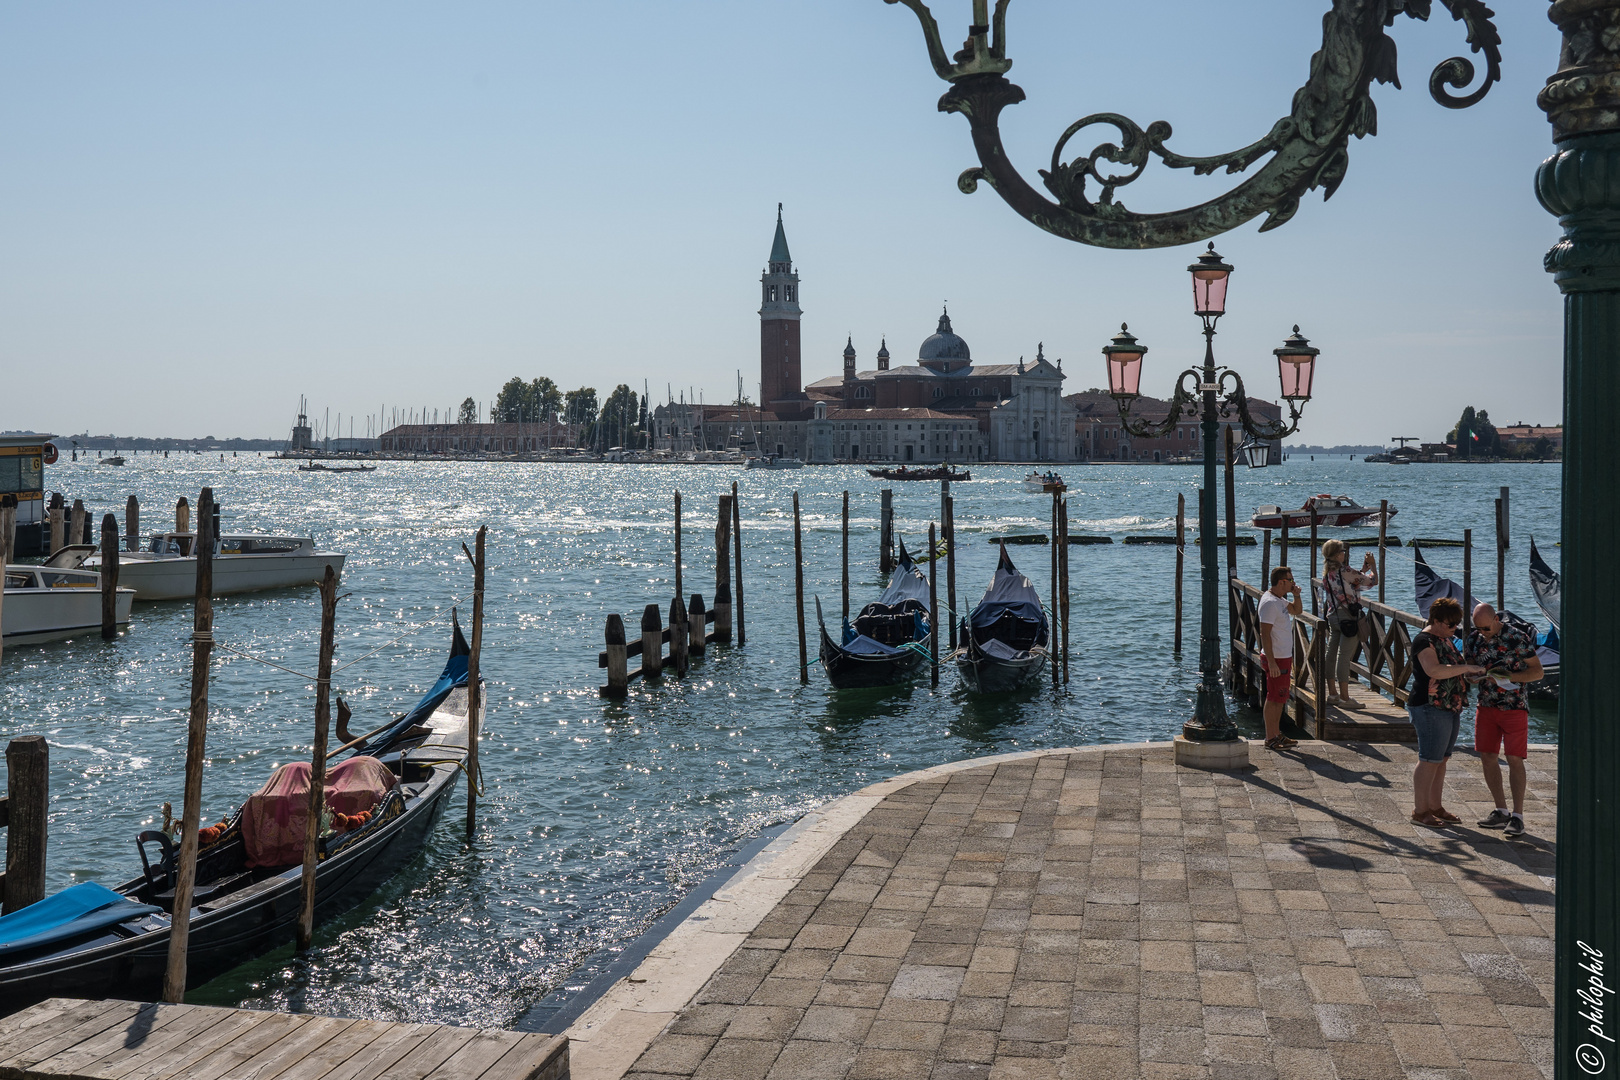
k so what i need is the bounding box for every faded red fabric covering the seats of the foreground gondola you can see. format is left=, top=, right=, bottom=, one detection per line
left=241, top=756, right=397, bottom=866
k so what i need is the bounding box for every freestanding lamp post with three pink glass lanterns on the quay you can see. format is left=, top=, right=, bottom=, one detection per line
left=1103, top=250, right=1320, bottom=742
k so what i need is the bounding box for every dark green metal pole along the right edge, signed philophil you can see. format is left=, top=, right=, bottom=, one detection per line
left=1536, top=12, right=1620, bottom=1080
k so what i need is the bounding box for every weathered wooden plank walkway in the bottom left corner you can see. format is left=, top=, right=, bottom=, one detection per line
left=0, top=997, right=569, bottom=1080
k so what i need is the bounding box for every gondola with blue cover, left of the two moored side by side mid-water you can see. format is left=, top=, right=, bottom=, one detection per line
left=815, top=541, right=928, bottom=690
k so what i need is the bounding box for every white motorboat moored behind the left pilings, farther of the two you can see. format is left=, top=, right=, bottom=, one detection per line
left=79, top=533, right=343, bottom=601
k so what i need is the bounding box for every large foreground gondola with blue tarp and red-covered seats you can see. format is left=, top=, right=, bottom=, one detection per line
left=0, top=625, right=468, bottom=1014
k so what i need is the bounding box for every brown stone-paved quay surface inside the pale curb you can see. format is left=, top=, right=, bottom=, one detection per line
left=614, top=742, right=1557, bottom=1080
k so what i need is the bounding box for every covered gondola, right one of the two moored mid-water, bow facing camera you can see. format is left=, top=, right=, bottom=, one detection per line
left=954, top=544, right=1048, bottom=693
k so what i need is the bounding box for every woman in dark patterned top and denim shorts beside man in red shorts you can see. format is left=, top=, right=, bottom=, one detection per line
left=1406, top=596, right=1486, bottom=829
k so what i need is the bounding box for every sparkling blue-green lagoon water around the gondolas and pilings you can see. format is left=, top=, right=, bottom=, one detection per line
left=0, top=455, right=1558, bottom=1025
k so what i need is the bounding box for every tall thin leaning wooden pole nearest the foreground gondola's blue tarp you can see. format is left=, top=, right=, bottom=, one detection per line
left=164, top=487, right=214, bottom=1002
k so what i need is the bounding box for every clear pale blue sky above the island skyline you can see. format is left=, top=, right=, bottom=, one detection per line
left=0, top=0, right=1562, bottom=445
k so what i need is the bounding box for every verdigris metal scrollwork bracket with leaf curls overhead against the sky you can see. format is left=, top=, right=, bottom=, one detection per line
left=885, top=0, right=1502, bottom=248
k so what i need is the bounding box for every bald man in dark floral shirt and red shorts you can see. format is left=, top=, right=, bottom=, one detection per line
left=1468, top=604, right=1542, bottom=836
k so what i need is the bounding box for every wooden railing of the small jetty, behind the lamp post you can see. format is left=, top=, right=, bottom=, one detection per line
left=1228, top=578, right=1424, bottom=730
